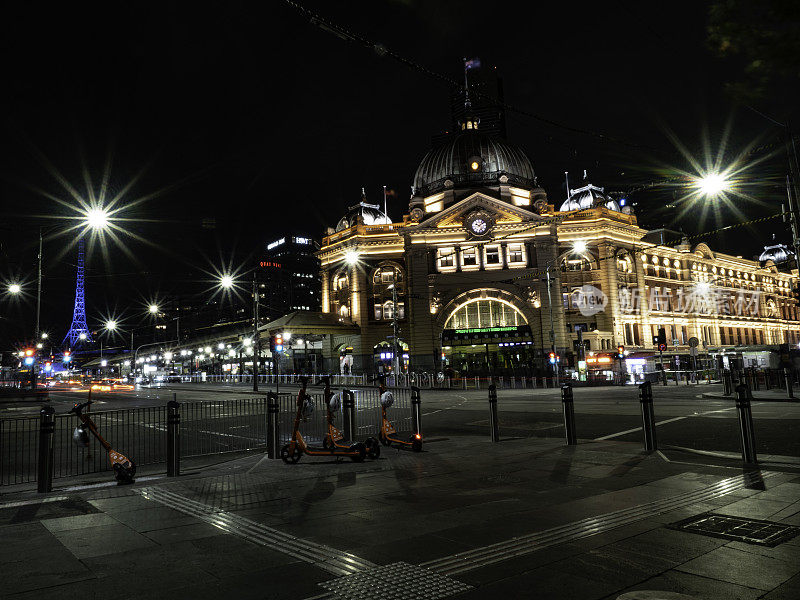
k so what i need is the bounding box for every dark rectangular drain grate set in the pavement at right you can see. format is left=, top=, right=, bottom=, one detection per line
left=667, top=513, right=800, bottom=547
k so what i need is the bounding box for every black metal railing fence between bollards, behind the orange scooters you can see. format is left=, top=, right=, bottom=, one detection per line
left=0, top=388, right=411, bottom=485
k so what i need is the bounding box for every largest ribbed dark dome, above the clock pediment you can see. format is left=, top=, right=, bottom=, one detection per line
left=414, top=130, right=536, bottom=196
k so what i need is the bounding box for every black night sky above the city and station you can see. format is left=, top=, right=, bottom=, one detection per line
left=0, top=0, right=800, bottom=350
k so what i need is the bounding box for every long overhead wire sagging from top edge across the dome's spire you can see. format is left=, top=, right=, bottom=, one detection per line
left=283, top=0, right=657, bottom=151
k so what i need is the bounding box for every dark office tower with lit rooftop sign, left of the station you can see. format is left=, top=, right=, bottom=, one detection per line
left=259, top=234, right=321, bottom=320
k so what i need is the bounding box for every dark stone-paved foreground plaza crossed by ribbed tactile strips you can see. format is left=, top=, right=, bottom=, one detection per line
left=0, top=436, right=800, bottom=600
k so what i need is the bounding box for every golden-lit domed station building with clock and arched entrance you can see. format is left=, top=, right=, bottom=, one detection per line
left=317, top=112, right=800, bottom=376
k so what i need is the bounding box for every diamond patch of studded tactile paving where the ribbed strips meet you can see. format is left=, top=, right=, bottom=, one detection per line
left=319, top=562, right=472, bottom=600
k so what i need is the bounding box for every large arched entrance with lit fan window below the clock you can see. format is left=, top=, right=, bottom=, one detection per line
left=442, top=290, right=535, bottom=377
